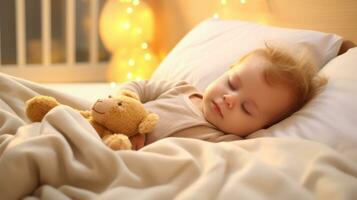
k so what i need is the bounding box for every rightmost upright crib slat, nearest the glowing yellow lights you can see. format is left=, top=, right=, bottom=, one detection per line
left=89, top=0, right=98, bottom=65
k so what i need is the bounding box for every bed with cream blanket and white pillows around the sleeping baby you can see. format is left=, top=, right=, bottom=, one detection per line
left=0, top=13, right=357, bottom=200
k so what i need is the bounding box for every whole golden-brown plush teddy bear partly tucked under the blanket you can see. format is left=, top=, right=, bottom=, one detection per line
left=26, top=90, right=159, bottom=150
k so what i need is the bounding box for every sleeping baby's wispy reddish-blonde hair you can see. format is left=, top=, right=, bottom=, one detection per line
left=238, top=43, right=327, bottom=118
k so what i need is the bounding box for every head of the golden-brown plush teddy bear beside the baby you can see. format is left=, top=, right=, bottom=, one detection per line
left=91, top=92, right=158, bottom=136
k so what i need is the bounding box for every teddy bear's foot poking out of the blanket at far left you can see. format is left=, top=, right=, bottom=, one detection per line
left=26, top=96, right=59, bottom=122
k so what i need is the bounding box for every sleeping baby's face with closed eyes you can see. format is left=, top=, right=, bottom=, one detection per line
left=203, top=55, right=296, bottom=137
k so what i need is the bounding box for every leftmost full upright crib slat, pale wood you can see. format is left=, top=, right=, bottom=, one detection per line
left=15, top=0, right=26, bottom=67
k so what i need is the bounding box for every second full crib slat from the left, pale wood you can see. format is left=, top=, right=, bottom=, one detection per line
left=41, top=0, right=51, bottom=66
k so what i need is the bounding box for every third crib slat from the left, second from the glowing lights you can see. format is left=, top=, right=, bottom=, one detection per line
left=66, top=0, right=76, bottom=66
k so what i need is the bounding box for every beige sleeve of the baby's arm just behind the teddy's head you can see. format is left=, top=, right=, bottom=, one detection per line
left=118, top=80, right=187, bottom=103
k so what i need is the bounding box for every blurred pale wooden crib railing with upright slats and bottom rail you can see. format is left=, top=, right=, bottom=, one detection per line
left=0, top=0, right=109, bottom=82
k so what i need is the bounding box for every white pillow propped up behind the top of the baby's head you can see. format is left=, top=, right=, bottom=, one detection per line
left=152, top=19, right=343, bottom=91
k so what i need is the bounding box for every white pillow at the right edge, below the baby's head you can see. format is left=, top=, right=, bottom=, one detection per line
left=248, top=47, right=357, bottom=161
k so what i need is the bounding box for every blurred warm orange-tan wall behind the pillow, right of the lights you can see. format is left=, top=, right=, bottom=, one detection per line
left=145, top=0, right=357, bottom=52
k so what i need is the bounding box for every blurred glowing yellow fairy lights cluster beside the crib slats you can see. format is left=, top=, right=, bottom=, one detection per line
left=99, top=0, right=158, bottom=82
